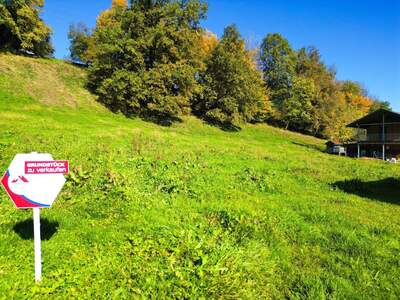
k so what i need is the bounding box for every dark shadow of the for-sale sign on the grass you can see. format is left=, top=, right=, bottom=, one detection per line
left=13, top=218, right=60, bottom=241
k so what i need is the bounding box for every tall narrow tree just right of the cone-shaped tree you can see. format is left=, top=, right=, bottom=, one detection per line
left=260, top=33, right=296, bottom=113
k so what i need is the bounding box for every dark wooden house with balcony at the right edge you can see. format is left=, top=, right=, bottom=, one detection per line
left=346, top=109, right=400, bottom=160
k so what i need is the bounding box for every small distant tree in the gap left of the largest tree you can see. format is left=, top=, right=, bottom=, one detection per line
left=68, top=22, right=92, bottom=64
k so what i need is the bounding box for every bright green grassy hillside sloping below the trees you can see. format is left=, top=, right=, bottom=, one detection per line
left=0, top=55, right=400, bottom=299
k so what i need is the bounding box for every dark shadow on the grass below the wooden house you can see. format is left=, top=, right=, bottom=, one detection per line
left=332, top=177, right=400, bottom=205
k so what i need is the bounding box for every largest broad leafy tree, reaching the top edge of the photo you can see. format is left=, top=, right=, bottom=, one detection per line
left=89, top=0, right=206, bottom=117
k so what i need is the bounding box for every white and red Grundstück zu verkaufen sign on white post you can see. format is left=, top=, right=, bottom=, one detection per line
left=1, top=152, right=69, bottom=282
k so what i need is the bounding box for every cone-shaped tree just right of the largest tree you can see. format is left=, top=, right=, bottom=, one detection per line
left=193, top=26, right=269, bottom=125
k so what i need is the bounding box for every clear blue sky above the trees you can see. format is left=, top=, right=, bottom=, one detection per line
left=43, top=0, right=400, bottom=111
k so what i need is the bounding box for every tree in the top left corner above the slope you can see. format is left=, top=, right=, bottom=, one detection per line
left=0, top=0, right=53, bottom=57
